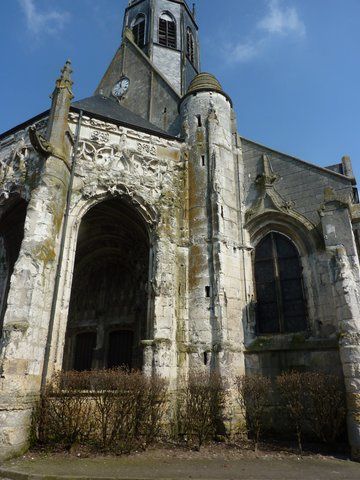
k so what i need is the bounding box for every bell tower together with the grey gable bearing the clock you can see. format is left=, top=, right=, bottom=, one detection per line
left=95, top=0, right=200, bottom=136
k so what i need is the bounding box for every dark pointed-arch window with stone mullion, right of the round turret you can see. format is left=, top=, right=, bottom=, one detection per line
left=255, top=232, right=307, bottom=334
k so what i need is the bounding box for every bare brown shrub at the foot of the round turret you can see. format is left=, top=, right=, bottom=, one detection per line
left=178, top=374, right=225, bottom=450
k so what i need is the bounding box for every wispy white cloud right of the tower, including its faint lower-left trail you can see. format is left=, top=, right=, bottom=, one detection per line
left=227, top=0, right=306, bottom=63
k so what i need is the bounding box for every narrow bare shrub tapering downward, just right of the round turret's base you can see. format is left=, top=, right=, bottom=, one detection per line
left=236, top=374, right=271, bottom=451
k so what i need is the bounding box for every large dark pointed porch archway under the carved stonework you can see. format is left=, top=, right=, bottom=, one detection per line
left=63, top=199, right=149, bottom=371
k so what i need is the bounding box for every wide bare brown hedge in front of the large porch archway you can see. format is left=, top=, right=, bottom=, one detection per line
left=36, top=369, right=167, bottom=453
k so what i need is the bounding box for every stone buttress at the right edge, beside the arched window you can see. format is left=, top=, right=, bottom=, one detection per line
left=321, top=189, right=360, bottom=461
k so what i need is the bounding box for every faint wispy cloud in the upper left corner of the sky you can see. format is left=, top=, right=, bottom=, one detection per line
left=19, top=0, right=69, bottom=35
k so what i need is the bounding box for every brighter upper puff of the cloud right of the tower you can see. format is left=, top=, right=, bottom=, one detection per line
left=258, top=0, right=306, bottom=37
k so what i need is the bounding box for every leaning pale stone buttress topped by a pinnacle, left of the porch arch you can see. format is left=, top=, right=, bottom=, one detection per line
left=0, top=62, right=73, bottom=459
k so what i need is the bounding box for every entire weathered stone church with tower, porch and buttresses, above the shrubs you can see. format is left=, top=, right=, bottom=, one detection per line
left=0, top=0, right=360, bottom=459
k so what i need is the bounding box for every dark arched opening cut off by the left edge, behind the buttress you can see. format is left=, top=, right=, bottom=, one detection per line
left=0, top=197, right=27, bottom=337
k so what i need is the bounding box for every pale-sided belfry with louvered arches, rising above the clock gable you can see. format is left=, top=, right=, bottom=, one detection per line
left=124, top=0, right=200, bottom=96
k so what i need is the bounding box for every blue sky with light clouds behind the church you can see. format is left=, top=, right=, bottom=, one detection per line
left=0, top=0, right=360, bottom=179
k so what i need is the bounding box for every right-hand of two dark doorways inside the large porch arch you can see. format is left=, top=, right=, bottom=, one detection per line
left=107, top=330, right=134, bottom=370
